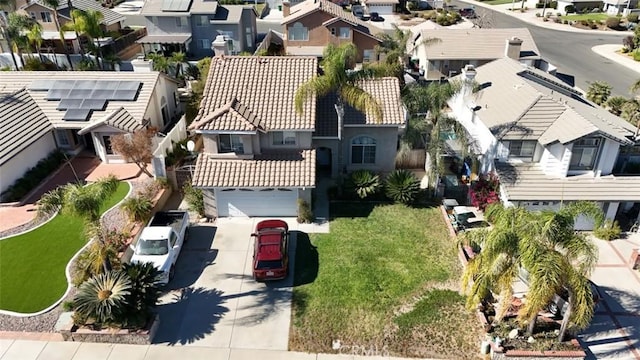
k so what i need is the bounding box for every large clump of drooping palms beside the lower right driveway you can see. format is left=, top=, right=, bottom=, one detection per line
left=462, top=202, right=603, bottom=341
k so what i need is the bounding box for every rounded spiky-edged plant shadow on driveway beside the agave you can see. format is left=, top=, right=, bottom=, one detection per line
left=152, top=287, right=229, bottom=345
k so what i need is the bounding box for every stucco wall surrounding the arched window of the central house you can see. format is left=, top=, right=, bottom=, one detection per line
left=342, top=127, right=398, bottom=172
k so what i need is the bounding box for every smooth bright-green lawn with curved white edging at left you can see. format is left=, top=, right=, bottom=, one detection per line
left=0, top=182, right=129, bottom=313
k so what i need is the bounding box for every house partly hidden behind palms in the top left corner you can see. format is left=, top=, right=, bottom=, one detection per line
left=16, top=0, right=125, bottom=54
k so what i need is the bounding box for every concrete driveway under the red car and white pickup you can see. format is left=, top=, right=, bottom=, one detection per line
left=154, top=218, right=296, bottom=350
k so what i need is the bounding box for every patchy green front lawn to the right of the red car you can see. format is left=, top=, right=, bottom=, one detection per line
left=289, top=203, right=479, bottom=359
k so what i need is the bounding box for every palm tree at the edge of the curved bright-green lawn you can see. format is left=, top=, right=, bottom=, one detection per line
left=37, top=175, right=119, bottom=272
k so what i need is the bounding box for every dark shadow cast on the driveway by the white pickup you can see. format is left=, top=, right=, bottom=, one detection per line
left=164, top=226, right=218, bottom=291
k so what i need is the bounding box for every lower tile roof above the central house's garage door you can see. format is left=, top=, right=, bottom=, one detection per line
left=192, top=150, right=316, bottom=188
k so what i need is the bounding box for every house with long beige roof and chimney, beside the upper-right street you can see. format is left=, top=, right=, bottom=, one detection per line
left=408, top=28, right=540, bottom=80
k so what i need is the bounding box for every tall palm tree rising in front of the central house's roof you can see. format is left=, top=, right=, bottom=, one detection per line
left=295, top=43, right=383, bottom=173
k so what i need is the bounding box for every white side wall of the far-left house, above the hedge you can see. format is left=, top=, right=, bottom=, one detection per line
left=0, top=133, right=56, bottom=193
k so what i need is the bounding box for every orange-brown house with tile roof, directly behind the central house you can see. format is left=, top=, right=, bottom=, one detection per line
left=282, top=0, right=382, bottom=62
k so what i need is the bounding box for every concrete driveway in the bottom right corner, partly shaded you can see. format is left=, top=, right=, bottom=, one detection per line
left=579, top=234, right=640, bottom=360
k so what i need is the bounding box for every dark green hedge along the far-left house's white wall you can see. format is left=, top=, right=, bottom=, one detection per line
left=2, top=151, right=66, bottom=202
